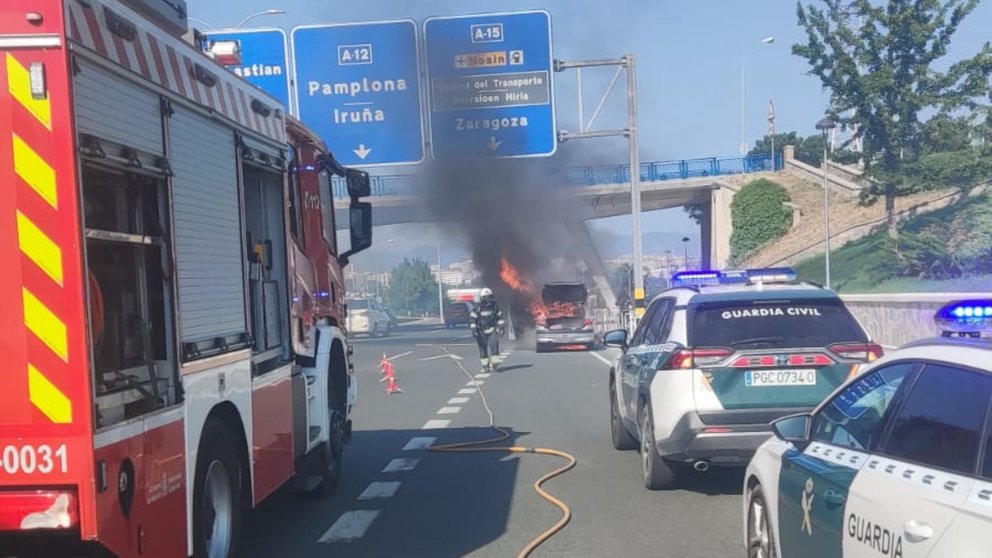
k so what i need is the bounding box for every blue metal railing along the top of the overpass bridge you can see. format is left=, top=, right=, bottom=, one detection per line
left=333, top=154, right=783, bottom=198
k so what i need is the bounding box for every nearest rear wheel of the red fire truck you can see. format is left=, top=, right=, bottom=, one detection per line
left=193, top=419, right=241, bottom=558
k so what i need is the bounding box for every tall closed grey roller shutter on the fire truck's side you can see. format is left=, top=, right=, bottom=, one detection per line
left=169, top=104, right=247, bottom=350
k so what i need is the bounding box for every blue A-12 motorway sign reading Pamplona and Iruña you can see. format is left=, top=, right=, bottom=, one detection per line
left=292, top=20, right=424, bottom=167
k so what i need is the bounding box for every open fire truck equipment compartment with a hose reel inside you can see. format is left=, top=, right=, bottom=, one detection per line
left=82, top=165, right=179, bottom=427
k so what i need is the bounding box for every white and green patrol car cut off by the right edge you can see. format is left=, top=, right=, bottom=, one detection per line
left=744, top=299, right=992, bottom=558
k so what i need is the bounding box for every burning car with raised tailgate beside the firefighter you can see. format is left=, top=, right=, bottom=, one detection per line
left=535, top=282, right=596, bottom=353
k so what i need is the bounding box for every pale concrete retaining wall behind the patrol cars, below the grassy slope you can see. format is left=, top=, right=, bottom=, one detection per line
left=841, top=293, right=989, bottom=347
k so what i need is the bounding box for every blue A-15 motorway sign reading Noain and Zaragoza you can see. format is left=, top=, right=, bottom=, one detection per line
left=424, top=11, right=558, bottom=159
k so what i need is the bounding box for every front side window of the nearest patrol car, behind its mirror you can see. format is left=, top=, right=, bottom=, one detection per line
left=812, top=363, right=916, bottom=450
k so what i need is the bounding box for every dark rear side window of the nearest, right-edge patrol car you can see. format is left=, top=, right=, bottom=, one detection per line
left=882, top=365, right=992, bottom=475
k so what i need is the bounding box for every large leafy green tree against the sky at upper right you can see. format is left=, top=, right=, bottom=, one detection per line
left=792, top=0, right=992, bottom=237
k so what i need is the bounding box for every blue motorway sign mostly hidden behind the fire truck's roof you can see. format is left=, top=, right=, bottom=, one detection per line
left=205, top=29, right=291, bottom=110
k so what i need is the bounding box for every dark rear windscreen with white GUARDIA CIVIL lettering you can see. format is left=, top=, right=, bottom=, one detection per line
left=689, top=299, right=868, bottom=349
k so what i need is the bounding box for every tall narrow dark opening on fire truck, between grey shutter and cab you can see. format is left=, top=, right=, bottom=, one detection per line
left=243, top=164, right=291, bottom=372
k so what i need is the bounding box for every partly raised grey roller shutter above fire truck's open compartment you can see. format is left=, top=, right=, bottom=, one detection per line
left=73, top=58, right=164, bottom=155
